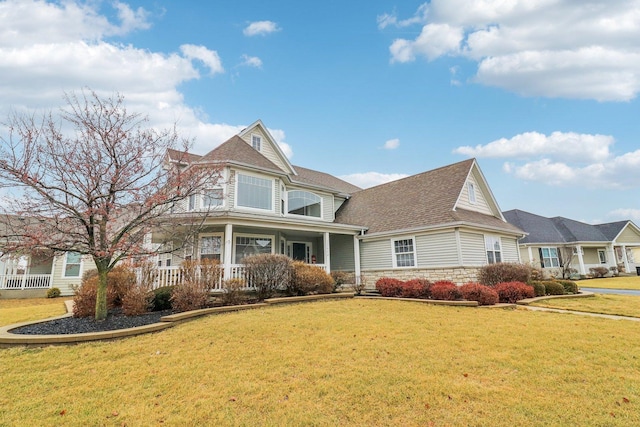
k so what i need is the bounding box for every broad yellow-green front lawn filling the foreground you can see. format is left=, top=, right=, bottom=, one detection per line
left=0, top=299, right=640, bottom=426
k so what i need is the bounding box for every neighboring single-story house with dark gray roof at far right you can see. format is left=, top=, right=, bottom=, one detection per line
left=503, top=210, right=640, bottom=276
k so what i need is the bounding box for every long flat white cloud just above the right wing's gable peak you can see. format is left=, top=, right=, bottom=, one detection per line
left=454, top=132, right=615, bottom=162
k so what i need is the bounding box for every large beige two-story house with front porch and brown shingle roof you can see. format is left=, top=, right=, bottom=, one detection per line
left=0, top=121, right=524, bottom=295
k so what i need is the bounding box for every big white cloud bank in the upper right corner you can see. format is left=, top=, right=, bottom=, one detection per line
left=378, top=0, right=640, bottom=101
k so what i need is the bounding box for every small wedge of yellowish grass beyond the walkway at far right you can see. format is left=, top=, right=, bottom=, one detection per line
left=531, top=294, right=640, bottom=317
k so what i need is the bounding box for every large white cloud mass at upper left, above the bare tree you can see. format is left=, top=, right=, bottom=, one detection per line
left=0, top=0, right=293, bottom=157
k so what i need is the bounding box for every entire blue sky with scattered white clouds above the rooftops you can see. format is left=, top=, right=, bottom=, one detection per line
left=0, top=0, right=640, bottom=224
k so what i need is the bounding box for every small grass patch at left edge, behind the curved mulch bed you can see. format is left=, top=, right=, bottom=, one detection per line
left=0, top=298, right=68, bottom=326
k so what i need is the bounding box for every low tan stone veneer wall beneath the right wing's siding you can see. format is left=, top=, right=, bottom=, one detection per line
left=362, top=267, right=480, bottom=289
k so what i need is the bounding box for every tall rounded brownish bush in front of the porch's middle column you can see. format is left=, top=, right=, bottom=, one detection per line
left=242, top=254, right=293, bottom=300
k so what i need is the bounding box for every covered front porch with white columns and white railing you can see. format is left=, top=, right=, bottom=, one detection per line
left=152, top=222, right=360, bottom=291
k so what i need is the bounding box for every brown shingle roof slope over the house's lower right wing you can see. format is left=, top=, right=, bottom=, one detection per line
left=336, top=159, right=520, bottom=233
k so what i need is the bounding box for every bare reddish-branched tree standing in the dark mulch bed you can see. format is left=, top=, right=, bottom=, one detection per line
left=0, top=90, right=219, bottom=320
